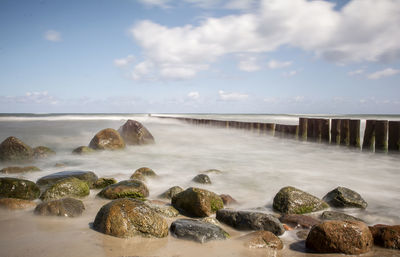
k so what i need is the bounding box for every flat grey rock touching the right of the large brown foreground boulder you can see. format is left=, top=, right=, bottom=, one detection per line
left=170, top=219, right=229, bottom=244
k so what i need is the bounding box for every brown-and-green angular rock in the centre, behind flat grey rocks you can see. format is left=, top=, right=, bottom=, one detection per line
left=171, top=187, right=224, bottom=217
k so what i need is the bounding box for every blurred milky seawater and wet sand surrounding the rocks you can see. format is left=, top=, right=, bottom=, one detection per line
left=0, top=115, right=400, bottom=256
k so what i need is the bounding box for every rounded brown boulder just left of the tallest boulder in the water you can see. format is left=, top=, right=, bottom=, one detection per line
left=89, top=128, right=125, bottom=150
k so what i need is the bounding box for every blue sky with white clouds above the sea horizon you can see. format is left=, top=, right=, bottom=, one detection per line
left=0, top=0, right=400, bottom=114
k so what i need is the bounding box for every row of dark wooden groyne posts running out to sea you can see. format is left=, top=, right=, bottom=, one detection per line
left=152, top=116, right=400, bottom=153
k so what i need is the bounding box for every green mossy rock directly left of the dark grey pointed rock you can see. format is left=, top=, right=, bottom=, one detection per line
left=273, top=187, right=329, bottom=214
